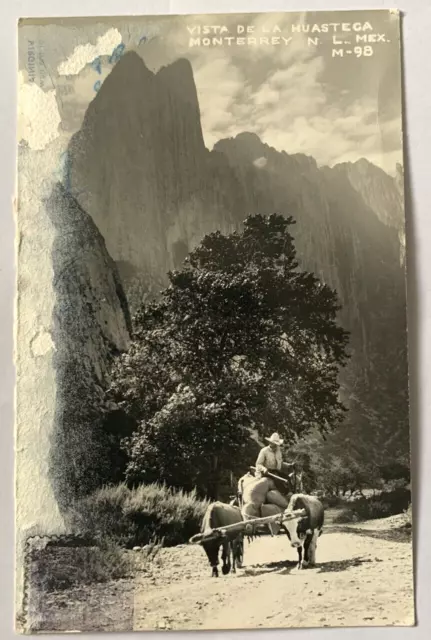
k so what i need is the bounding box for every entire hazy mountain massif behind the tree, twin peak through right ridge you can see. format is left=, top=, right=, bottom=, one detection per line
left=67, top=53, right=408, bottom=458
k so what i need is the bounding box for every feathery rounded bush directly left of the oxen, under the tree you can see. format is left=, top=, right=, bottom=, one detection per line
left=65, top=484, right=209, bottom=548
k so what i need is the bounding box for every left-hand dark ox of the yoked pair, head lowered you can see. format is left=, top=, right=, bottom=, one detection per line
left=201, top=502, right=244, bottom=578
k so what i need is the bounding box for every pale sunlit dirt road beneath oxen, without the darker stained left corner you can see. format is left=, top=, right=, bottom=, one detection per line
left=134, top=531, right=413, bottom=630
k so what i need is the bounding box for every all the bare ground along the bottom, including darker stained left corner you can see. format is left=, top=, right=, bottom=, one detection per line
left=26, top=516, right=414, bottom=631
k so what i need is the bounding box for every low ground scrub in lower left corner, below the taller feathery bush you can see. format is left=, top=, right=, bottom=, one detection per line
left=30, top=541, right=133, bottom=592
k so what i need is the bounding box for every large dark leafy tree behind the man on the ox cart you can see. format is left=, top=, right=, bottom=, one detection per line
left=109, top=214, right=348, bottom=497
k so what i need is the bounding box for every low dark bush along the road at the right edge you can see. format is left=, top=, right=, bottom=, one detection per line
left=334, top=488, right=410, bottom=524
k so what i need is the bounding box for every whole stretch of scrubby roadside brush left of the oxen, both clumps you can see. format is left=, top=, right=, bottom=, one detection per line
left=29, top=484, right=209, bottom=593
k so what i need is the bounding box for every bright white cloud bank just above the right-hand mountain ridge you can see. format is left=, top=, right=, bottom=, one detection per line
left=191, top=32, right=401, bottom=173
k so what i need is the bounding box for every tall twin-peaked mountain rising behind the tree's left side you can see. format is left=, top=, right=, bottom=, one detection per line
left=68, top=52, right=241, bottom=298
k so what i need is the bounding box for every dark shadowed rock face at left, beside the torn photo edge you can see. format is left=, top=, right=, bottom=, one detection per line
left=46, top=185, right=130, bottom=507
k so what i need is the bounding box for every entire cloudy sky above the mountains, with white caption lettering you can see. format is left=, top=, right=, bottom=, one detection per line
left=19, top=11, right=402, bottom=174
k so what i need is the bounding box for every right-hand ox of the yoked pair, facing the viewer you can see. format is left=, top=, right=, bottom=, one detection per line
left=283, top=493, right=324, bottom=569
